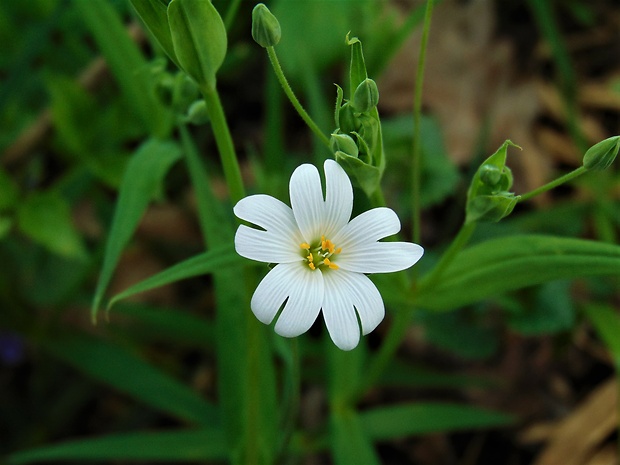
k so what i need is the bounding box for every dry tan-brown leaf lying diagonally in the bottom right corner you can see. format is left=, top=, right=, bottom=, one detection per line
left=535, top=379, right=618, bottom=465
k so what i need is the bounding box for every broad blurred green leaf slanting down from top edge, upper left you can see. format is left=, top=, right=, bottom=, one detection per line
left=73, top=0, right=171, bottom=137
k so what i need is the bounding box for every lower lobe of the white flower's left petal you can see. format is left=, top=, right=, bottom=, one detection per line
left=235, top=225, right=303, bottom=263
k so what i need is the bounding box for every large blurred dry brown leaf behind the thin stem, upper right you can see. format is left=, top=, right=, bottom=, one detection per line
left=379, top=0, right=549, bottom=190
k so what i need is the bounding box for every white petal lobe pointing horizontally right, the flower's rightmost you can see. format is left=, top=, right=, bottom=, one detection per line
left=335, top=242, right=424, bottom=273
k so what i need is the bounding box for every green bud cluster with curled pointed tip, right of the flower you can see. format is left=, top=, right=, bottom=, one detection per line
left=465, top=140, right=521, bottom=223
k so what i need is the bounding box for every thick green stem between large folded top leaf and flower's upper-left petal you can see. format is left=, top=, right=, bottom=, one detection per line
left=201, top=86, right=245, bottom=203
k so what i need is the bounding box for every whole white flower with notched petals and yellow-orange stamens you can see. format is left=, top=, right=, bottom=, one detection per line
left=234, top=160, right=424, bottom=350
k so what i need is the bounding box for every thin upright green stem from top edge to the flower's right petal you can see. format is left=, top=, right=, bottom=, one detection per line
left=411, top=0, right=433, bottom=244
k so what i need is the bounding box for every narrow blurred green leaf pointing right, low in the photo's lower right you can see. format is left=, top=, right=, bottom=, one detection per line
left=360, top=402, right=515, bottom=441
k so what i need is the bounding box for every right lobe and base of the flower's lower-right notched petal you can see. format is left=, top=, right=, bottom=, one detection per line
left=323, top=269, right=385, bottom=334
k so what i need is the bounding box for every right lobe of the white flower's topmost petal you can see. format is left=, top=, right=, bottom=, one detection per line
left=323, top=160, right=353, bottom=239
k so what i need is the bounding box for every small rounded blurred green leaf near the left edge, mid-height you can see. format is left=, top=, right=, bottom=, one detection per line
left=17, top=192, right=87, bottom=259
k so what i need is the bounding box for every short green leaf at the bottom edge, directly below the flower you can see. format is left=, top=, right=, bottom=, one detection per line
left=331, top=409, right=381, bottom=465
